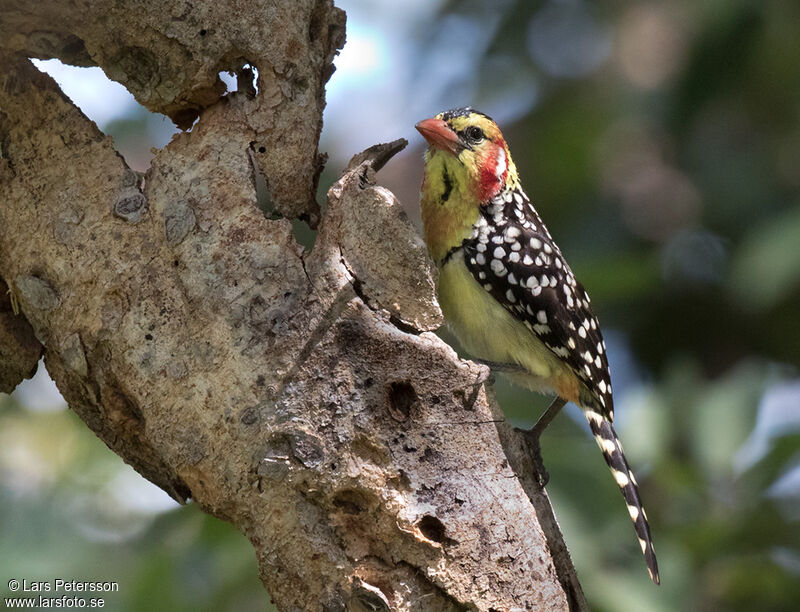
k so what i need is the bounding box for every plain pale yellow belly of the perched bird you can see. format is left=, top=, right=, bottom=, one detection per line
left=438, top=251, right=577, bottom=401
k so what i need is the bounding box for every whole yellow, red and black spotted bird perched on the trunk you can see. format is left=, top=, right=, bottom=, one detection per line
left=415, top=107, right=660, bottom=584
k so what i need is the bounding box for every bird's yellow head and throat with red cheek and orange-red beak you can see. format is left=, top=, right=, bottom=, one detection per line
left=416, top=108, right=519, bottom=262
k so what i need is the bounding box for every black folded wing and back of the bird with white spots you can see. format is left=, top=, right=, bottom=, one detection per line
left=462, top=188, right=614, bottom=418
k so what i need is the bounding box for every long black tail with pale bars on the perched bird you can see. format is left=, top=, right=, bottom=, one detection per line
left=584, top=409, right=661, bottom=584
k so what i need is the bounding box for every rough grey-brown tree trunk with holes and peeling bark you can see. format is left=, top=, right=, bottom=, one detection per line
left=0, top=0, right=585, bottom=610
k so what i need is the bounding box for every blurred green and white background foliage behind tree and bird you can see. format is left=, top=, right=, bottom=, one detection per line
left=0, top=0, right=800, bottom=612
